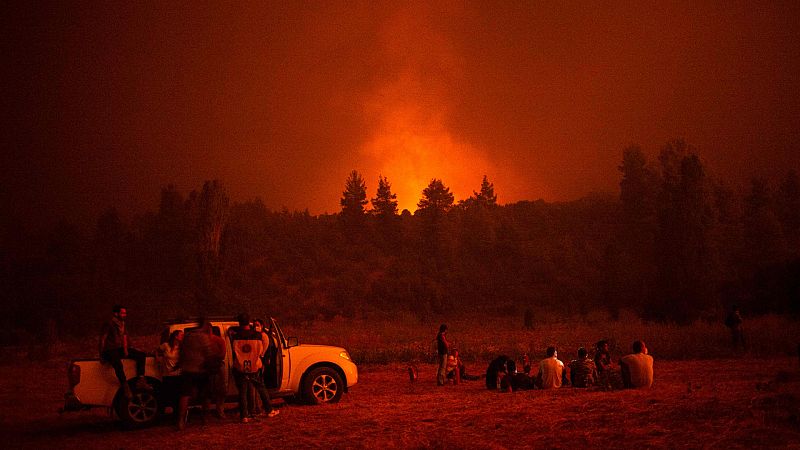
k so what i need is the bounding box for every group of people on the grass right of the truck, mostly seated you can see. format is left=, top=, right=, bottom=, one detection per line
left=436, top=324, right=653, bottom=392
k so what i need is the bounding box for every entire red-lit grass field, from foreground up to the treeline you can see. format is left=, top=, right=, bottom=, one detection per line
left=0, top=319, right=800, bottom=449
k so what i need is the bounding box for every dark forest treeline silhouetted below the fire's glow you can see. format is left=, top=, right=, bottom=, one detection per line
left=0, top=140, right=800, bottom=341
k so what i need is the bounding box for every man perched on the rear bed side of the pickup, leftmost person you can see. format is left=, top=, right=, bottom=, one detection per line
left=99, top=305, right=153, bottom=399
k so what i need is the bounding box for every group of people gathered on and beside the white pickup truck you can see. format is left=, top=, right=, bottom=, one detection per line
left=100, top=305, right=278, bottom=430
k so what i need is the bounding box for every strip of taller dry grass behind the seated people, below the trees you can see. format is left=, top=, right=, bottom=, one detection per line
left=283, top=311, right=800, bottom=366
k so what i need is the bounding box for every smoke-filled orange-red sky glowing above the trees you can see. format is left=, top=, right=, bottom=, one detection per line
left=0, top=1, right=800, bottom=229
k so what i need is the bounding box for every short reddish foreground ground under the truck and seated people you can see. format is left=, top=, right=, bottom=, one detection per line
left=0, top=358, right=800, bottom=449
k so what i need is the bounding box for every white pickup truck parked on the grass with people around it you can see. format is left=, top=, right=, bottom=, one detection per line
left=62, top=318, right=358, bottom=427
